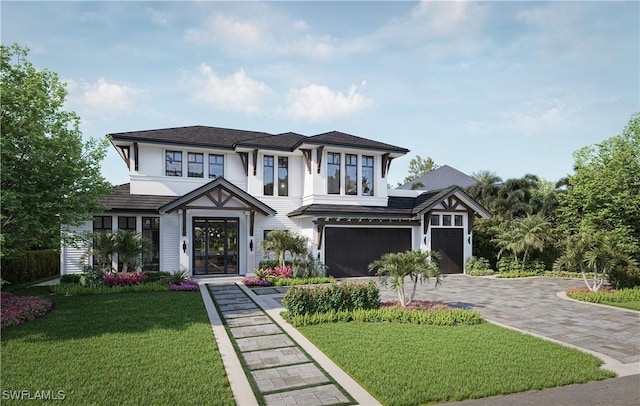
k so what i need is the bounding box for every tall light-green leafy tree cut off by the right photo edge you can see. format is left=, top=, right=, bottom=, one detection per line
left=558, top=113, right=640, bottom=259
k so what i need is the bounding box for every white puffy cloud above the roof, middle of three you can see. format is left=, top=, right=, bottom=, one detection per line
left=195, top=63, right=273, bottom=114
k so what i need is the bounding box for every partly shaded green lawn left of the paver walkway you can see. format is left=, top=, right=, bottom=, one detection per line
left=0, top=288, right=234, bottom=405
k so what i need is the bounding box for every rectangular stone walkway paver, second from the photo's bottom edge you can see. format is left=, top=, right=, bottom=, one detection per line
left=251, top=364, right=329, bottom=392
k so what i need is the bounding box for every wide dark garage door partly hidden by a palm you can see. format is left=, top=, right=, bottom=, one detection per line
left=324, top=227, right=411, bottom=277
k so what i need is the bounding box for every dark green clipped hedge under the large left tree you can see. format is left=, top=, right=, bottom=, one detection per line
left=2, top=249, right=60, bottom=284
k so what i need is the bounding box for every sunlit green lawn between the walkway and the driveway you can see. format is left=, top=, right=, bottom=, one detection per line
left=298, top=323, right=615, bottom=405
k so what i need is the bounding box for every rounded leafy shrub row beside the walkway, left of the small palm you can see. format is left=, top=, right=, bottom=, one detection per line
left=282, top=282, right=380, bottom=316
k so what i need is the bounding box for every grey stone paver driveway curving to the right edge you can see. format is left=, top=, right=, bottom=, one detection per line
left=381, top=275, right=640, bottom=373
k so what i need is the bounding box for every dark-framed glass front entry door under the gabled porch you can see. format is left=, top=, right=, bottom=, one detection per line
left=193, top=218, right=238, bottom=275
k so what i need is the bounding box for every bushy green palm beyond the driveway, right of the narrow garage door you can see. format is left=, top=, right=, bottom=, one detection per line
left=494, top=214, right=554, bottom=265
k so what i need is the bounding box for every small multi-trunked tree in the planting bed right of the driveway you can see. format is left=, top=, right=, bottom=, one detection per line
left=554, top=230, right=638, bottom=292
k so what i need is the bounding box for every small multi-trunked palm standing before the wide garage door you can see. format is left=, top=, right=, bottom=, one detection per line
left=369, top=250, right=442, bottom=307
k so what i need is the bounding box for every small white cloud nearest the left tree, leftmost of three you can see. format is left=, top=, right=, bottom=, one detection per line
left=77, top=78, right=145, bottom=114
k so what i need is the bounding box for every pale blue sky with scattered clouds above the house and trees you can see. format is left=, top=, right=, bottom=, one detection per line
left=1, top=1, right=640, bottom=185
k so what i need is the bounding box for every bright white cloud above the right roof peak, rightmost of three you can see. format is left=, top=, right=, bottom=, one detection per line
left=286, top=84, right=373, bottom=121
